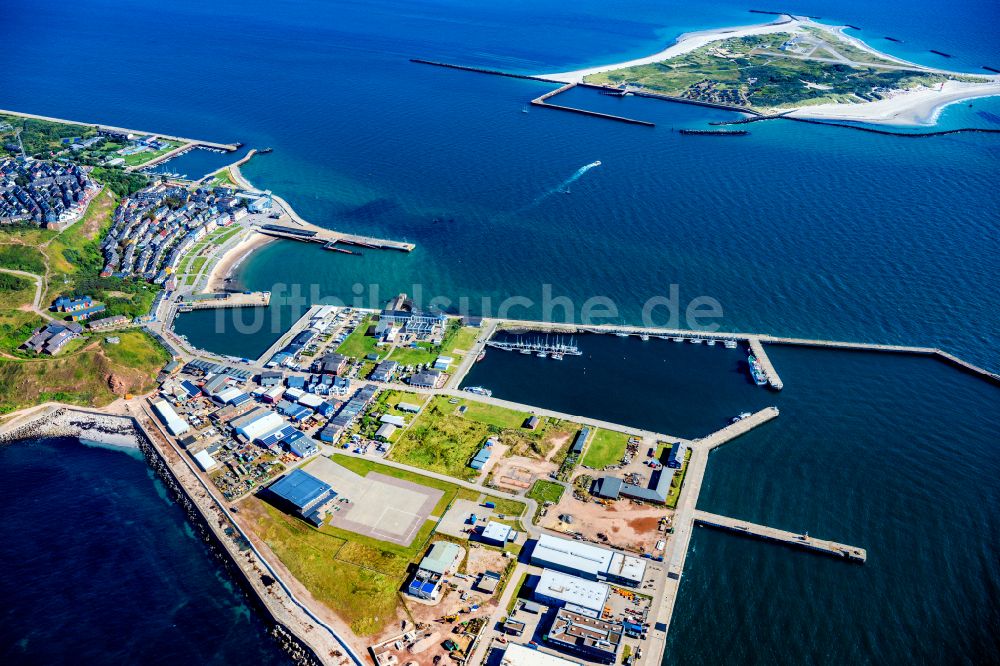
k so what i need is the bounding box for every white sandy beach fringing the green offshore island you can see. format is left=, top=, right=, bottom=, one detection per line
left=540, top=15, right=1000, bottom=126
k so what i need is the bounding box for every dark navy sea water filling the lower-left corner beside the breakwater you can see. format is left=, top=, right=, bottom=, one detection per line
left=0, top=439, right=287, bottom=666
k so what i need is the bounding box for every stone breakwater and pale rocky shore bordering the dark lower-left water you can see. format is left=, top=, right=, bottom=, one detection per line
left=0, top=407, right=324, bottom=666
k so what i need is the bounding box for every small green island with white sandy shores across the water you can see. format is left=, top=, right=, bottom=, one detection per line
left=539, top=16, right=1000, bottom=125
